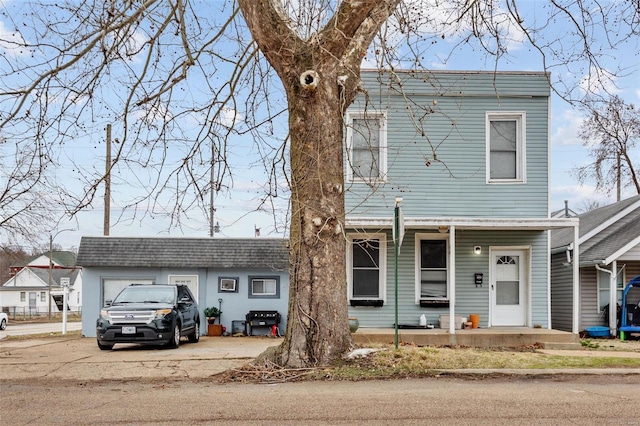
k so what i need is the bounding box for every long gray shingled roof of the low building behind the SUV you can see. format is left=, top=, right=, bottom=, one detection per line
left=77, top=237, right=289, bottom=271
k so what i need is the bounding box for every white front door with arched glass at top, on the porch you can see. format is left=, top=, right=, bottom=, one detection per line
left=491, top=250, right=528, bottom=326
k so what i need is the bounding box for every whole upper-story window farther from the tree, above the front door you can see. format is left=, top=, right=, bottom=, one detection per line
left=486, top=112, right=526, bottom=183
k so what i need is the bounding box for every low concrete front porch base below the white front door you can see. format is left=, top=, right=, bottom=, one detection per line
left=352, top=327, right=580, bottom=348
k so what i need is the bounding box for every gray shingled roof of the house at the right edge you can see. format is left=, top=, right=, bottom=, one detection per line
left=551, top=195, right=640, bottom=262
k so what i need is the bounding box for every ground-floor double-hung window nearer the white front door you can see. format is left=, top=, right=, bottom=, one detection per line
left=416, top=234, right=449, bottom=303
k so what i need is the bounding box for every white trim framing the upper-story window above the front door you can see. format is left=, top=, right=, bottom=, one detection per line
left=485, top=111, right=527, bottom=183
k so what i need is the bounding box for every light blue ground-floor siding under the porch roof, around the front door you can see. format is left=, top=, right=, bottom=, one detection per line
left=349, top=229, right=549, bottom=328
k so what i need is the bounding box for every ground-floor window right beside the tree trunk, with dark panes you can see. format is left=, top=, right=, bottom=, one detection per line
left=347, top=234, right=387, bottom=306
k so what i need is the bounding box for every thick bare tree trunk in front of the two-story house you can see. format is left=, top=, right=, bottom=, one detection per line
left=238, top=0, right=399, bottom=367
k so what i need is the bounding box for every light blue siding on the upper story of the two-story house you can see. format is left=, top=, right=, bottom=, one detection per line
left=345, top=72, right=549, bottom=218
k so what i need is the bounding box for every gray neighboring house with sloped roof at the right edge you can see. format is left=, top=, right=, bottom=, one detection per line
left=551, top=195, right=640, bottom=335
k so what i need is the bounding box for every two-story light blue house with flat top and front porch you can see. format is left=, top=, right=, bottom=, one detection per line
left=345, top=71, right=578, bottom=333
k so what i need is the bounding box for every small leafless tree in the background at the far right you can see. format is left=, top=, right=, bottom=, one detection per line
left=574, top=95, right=640, bottom=201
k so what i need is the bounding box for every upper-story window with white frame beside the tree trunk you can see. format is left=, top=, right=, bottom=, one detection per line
left=347, top=112, right=387, bottom=183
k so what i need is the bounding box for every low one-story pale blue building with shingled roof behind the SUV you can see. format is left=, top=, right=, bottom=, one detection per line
left=78, top=237, right=289, bottom=337
